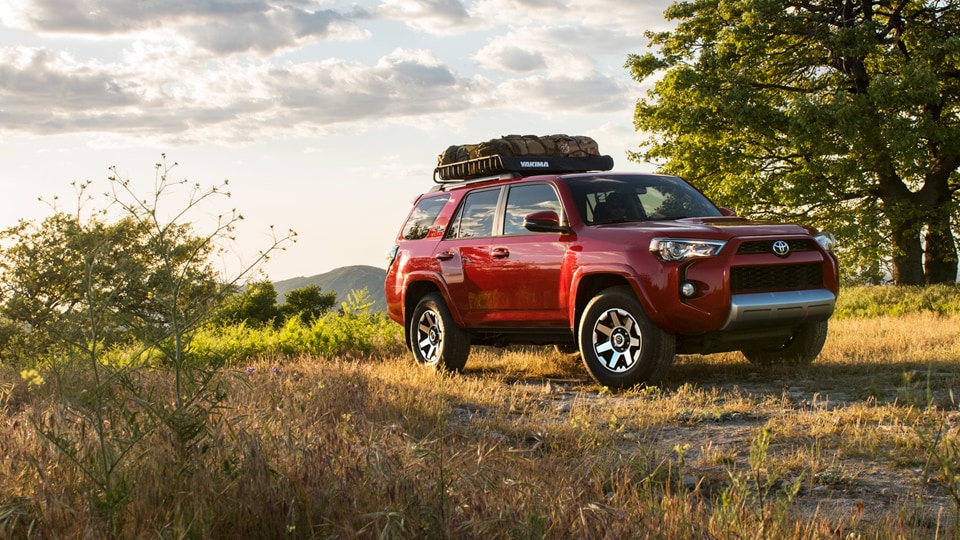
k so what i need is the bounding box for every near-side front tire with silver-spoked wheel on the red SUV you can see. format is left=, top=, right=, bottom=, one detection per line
left=577, top=287, right=676, bottom=389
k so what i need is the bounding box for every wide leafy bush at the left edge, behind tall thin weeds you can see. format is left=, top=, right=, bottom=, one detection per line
left=0, top=212, right=223, bottom=357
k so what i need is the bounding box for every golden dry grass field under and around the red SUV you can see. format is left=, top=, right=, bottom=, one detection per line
left=0, top=314, right=960, bottom=538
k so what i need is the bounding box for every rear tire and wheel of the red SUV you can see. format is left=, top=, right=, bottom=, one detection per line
left=407, top=293, right=470, bottom=372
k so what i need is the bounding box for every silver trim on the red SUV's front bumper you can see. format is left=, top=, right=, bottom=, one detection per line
left=721, top=289, right=837, bottom=330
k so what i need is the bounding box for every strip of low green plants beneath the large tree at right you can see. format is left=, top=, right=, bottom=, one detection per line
left=834, top=285, right=960, bottom=319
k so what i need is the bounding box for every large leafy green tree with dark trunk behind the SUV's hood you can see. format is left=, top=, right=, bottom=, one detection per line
left=627, top=0, right=960, bottom=285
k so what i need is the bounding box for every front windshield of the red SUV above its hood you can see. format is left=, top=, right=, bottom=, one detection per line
left=566, top=174, right=722, bottom=225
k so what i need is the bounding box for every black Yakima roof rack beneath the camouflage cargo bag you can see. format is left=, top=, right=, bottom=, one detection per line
left=433, top=154, right=613, bottom=184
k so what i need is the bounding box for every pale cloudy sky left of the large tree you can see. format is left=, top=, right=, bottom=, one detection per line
left=0, top=0, right=670, bottom=281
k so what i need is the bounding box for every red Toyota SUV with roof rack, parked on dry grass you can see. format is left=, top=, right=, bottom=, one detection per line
left=384, top=152, right=839, bottom=388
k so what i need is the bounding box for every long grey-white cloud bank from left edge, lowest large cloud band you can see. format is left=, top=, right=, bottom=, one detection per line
left=0, top=44, right=491, bottom=141
